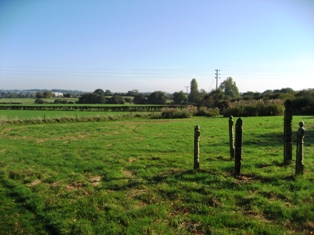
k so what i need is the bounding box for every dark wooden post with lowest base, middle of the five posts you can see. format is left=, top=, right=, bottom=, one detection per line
left=234, top=118, right=243, bottom=177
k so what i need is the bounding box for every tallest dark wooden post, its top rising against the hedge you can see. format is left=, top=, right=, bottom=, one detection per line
left=283, top=100, right=292, bottom=165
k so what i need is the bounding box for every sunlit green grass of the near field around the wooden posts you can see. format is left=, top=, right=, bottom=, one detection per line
left=0, top=116, right=314, bottom=235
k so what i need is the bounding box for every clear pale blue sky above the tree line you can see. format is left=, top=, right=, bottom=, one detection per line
left=0, top=0, right=314, bottom=93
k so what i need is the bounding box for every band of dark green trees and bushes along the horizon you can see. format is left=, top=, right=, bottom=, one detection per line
left=0, top=77, right=314, bottom=116
